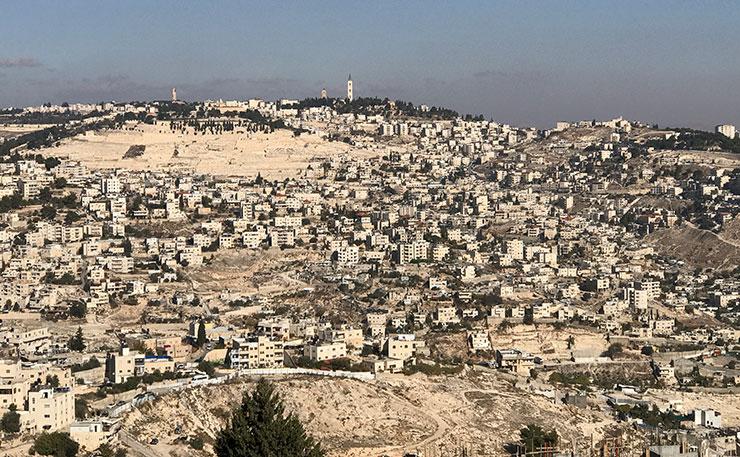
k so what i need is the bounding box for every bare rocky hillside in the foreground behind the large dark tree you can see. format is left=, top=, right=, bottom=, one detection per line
left=123, top=371, right=632, bottom=457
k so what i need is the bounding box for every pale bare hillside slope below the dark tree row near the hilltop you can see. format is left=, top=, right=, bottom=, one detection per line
left=44, top=123, right=370, bottom=179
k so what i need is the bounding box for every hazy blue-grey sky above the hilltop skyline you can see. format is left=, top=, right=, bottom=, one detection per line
left=0, top=0, right=740, bottom=128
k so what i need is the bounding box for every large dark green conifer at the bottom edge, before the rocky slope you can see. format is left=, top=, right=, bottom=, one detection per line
left=214, top=379, right=325, bottom=457
